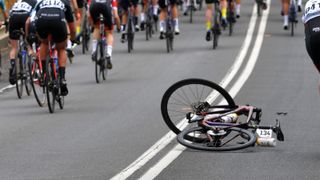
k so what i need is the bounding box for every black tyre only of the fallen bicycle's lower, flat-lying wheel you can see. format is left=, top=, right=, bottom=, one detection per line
left=177, top=127, right=256, bottom=151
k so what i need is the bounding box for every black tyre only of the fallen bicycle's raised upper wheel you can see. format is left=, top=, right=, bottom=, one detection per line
left=161, top=78, right=235, bottom=138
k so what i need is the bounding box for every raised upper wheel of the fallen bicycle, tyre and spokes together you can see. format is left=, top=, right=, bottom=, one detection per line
left=161, top=78, right=235, bottom=139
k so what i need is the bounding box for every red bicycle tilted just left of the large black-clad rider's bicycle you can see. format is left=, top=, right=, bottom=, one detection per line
left=28, top=34, right=47, bottom=107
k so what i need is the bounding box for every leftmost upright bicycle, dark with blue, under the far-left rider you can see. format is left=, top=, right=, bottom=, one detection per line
left=13, top=30, right=32, bottom=99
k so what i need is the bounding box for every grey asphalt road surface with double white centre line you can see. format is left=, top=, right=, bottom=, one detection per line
left=0, top=1, right=320, bottom=180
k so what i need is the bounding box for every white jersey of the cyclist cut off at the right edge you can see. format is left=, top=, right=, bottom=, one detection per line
left=302, top=0, right=320, bottom=23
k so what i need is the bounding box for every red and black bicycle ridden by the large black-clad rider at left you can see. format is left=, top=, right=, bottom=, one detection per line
left=44, top=35, right=64, bottom=113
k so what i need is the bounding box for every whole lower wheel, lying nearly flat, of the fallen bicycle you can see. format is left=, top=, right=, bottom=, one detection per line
left=177, top=127, right=256, bottom=151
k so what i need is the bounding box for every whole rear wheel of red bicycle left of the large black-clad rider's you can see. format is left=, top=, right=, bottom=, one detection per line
left=29, top=59, right=46, bottom=107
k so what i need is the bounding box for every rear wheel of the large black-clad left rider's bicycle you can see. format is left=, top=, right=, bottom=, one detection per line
left=45, top=58, right=56, bottom=113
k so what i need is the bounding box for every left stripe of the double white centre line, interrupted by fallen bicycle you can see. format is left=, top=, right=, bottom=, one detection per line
left=111, top=3, right=257, bottom=180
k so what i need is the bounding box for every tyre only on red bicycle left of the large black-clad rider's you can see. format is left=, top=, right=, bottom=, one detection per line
left=29, top=60, right=46, bottom=107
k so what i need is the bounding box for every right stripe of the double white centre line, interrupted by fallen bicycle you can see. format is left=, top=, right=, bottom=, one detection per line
left=140, top=0, right=270, bottom=180
